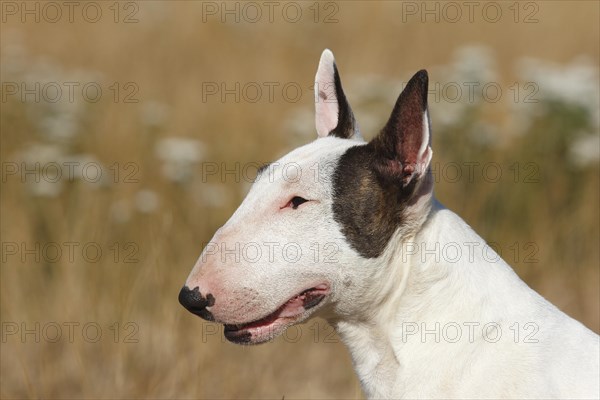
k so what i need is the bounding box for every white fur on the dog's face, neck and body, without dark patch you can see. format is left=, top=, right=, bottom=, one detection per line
left=186, top=53, right=600, bottom=399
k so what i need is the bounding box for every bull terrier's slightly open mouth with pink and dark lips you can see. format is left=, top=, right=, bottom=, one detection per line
left=223, top=284, right=329, bottom=344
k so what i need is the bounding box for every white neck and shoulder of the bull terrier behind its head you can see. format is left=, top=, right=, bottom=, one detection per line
left=333, top=203, right=600, bottom=399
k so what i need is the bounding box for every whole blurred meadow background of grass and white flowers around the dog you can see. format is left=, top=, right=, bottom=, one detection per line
left=0, top=1, right=600, bottom=399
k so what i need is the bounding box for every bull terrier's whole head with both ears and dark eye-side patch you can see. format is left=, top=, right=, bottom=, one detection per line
left=179, top=50, right=432, bottom=344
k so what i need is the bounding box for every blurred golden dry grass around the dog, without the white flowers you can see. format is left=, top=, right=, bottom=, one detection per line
left=0, top=1, right=600, bottom=399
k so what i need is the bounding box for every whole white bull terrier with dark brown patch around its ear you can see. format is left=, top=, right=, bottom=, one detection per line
left=179, top=50, right=600, bottom=399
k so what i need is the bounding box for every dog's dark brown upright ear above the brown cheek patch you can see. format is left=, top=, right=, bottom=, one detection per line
left=372, top=70, right=433, bottom=187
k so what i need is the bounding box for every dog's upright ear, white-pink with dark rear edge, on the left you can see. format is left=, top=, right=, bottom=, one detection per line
left=315, top=49, right=360, bottom=139
